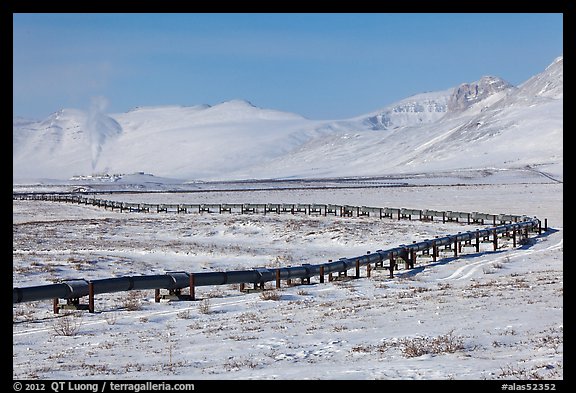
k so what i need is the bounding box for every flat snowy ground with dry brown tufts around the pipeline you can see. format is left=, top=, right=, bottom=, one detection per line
left=12, top=179, right=564, bottom=380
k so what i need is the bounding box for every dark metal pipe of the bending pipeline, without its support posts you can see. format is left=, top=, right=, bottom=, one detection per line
left=12, top=199, right=540, bottom=303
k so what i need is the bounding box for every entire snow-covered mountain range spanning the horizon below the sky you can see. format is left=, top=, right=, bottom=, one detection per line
left=13, top=56, right=563, bottom=181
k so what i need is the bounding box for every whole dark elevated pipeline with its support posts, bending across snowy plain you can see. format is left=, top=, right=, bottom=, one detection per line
left=12, top=194, right=547, bottom=310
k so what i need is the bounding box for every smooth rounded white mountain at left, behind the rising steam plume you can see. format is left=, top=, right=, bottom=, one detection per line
left=13, top=100, right=326, bottom=179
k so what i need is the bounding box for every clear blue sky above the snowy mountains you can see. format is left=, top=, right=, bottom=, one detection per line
left=13, top=13, right=563, bottom=119
